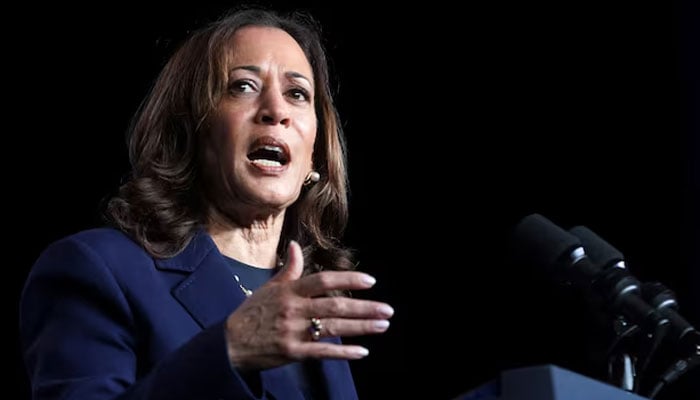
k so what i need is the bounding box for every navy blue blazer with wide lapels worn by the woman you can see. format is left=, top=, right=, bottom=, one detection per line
left=20, top=228, right=357, bottom=400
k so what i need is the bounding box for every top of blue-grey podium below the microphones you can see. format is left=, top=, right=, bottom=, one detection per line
left=453, top=365, right=649, bottom=400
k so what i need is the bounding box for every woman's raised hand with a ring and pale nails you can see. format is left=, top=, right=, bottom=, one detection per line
left=226, top=241, right=394, bottom=370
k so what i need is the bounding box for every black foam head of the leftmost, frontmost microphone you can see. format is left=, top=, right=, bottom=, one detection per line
left=512, top=214, right=583, bottom=274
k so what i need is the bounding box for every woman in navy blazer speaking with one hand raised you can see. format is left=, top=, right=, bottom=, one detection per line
left=20, top=9, right=393, bottom=400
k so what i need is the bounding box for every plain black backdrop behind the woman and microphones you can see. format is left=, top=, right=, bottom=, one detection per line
left=4, top=0, right=700, bottom=399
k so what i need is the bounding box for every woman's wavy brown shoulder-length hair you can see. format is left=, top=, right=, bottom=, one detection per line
left=105, top=9, right=354, bottom=282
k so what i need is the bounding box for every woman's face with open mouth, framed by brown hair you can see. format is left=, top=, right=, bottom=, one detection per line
left=204, top=27, right=317, bottom=216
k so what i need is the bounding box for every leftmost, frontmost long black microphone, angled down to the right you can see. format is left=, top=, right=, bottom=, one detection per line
left=513, top=214, right=668, bottom=332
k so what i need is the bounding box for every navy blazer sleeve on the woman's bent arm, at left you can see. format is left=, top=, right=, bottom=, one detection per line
left=20, top=239, right=266, bottom=400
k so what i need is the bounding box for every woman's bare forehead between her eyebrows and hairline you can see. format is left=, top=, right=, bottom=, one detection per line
left=229, top=26, right=312, bottom=78
